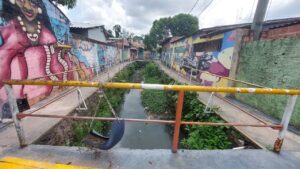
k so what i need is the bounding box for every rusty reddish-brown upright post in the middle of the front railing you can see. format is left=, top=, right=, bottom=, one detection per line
left=172, top=90, right=184, bottom=153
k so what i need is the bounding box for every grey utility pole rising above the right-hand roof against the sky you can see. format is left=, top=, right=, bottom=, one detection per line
left=251, top=0, right=269, bottom=40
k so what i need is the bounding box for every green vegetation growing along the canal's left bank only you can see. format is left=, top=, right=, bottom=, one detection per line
left=68, top=63, right=141, bottom=146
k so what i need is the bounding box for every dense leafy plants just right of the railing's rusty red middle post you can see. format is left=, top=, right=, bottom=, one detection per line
left=181, top=92, right=233, bottom=149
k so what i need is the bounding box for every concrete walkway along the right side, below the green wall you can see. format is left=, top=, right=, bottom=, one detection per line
left=157, top=62, right=300, bottom=151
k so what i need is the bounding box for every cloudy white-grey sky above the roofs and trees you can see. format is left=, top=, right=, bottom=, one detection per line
left=61, top=0, right=300, bottom=34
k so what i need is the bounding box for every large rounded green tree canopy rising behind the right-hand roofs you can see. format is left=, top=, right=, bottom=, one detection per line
left=144, top=14, right=199, bottom=51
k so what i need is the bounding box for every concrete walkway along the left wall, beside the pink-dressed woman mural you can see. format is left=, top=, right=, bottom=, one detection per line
left=0, top=63, right=129, bottom=154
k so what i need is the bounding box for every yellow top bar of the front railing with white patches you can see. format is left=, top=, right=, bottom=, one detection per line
left=3, top=80, right=300, bottom=95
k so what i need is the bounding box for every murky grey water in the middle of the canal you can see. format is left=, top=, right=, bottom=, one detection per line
left=118, top=90, right=172, bottom=149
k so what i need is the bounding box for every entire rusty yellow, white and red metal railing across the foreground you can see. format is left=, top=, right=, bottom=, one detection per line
left=3, top=80, right=300, bottom=153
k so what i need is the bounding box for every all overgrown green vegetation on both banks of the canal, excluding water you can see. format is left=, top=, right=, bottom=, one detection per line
left=62, top=62, right=253, bottom=149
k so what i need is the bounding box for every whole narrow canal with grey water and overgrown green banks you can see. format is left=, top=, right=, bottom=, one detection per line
left=36, top=62, right=257, bottom=150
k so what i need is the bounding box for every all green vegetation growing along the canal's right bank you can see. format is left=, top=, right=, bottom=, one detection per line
left=142, top=62, right=246, bottom=149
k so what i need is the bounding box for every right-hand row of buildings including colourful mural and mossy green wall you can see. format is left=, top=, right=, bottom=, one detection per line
left=161, top=17, right=300, bottom=127
